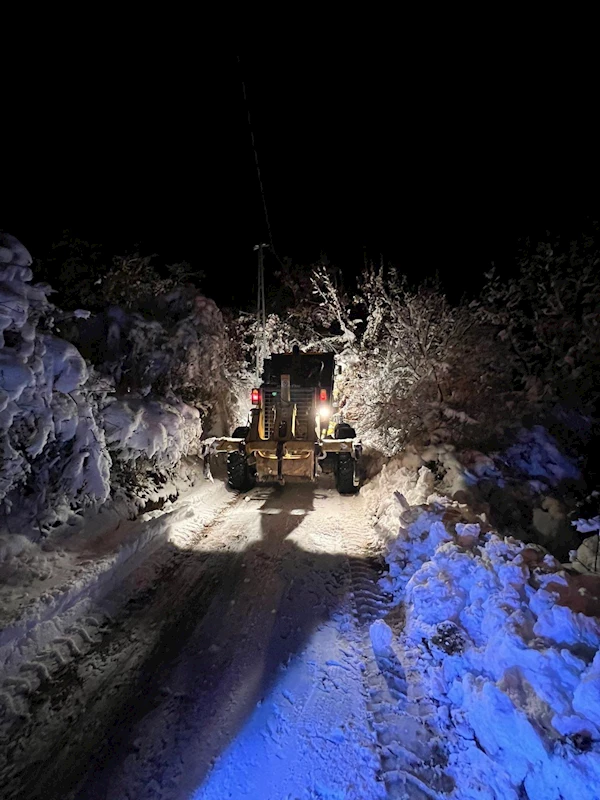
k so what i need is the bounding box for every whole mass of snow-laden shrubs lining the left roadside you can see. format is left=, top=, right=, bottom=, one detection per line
left=0, top=235, right=247, bottom=532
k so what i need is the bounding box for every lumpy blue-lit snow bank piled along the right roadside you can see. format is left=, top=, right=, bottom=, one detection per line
left=371, top=462, right=600, bottom=800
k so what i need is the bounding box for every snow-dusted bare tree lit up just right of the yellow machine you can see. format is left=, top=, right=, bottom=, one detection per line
left=341, top=267, right=515, bottom=454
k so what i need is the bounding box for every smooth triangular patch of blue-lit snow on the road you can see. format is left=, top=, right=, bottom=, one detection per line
left=193, top=580, right=386, bottom=800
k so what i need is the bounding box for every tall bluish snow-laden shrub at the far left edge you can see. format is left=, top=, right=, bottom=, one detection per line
left=0, top=234, right=111, bottom=526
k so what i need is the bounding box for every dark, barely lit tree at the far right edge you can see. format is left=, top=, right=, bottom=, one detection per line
left=478, top=230, right=600, bottom=412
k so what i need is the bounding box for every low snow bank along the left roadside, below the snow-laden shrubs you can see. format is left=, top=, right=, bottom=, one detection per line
left=0, top=466, right=234, bottom=675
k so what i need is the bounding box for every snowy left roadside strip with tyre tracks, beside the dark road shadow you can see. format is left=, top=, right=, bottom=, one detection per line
left=0, top=468, right=236, bottom=766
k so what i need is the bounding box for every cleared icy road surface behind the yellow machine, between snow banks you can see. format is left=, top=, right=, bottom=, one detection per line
left=0, top=485, right=403, bottom=800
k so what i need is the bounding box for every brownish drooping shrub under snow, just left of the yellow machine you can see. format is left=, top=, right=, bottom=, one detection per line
left=60, top=276, right=249, bottom=433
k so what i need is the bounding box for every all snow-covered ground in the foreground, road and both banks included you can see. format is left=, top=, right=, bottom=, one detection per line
left=0, top=440, right=600, bottom=800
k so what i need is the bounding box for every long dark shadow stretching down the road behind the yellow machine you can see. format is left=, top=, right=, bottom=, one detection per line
left=15, top=485, right=356, bottom=800
